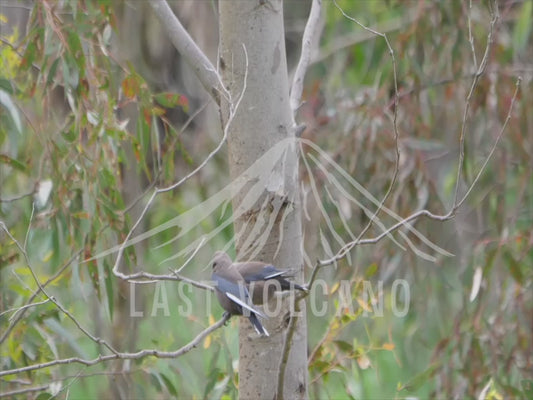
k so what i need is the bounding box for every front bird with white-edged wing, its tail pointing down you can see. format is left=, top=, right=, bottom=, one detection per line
left=211, top=251, right=268, bottom=336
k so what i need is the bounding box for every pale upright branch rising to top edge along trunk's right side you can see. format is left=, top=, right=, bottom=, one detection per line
left=290, top=0, right=322, bottom=115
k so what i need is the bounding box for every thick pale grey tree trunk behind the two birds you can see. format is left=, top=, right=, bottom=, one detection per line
left=219, top=0, right=307, bottom=400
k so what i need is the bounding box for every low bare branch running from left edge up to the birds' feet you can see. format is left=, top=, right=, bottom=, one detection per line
left=0, top=314, right=230, bottom=376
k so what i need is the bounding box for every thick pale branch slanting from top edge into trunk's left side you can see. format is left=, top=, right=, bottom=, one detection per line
left=150, top=0, right=223, bottom=106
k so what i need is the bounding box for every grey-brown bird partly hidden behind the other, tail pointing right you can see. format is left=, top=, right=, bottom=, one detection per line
left=233, top=261, right=308, bottom=304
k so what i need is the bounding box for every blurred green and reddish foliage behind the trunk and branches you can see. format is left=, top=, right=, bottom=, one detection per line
left=0, top=0, right=533, bottom=399
